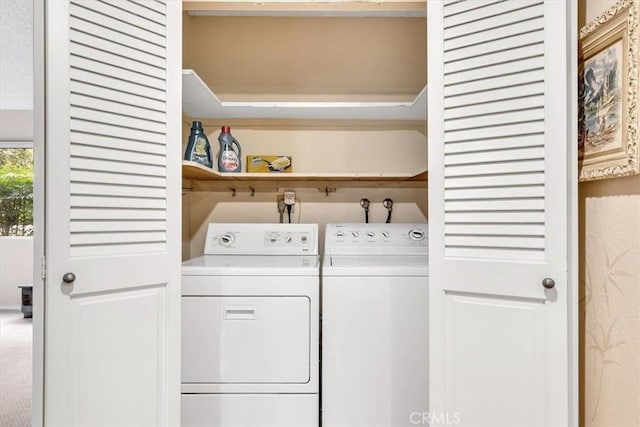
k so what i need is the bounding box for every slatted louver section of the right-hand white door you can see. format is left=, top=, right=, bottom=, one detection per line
left=443, top=1, right=545, bottom=259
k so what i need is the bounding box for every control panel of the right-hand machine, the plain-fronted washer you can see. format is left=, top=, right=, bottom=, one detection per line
left=324, top=223, right=429, bottom=255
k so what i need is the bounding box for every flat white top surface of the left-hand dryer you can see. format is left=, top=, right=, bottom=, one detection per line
left=182, top=255, right=320, bottom=276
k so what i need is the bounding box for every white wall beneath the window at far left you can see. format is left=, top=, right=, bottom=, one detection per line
left=0, top=237, right=33, bottom=309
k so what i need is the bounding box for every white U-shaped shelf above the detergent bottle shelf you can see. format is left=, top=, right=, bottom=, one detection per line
left=182, top=70, right=427, bottom=120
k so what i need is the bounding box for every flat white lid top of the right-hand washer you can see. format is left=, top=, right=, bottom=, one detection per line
left=322, top=255, right=429, bottom=276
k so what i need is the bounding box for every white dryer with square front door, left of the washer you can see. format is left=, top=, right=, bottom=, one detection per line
left=182, top=224, right=320, bottom=427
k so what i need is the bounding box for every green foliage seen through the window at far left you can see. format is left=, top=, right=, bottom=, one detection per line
left=0, top=148, right=33, bottom=236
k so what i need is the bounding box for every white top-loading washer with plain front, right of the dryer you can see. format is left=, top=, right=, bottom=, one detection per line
left=322, top=224, right=429, bottom=427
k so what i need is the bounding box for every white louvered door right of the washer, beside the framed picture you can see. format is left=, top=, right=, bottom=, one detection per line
left=428, top=0, right=577, bottom=426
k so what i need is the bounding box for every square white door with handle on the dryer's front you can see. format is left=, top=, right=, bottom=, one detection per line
left=182, top=296, right=311, bottom=384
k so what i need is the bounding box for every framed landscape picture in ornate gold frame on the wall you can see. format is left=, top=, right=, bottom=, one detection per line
left=578, top=0, right=640, bottom=181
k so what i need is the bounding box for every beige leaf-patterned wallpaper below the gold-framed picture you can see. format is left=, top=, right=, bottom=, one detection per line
left=581, top=195, right=640, bottom=426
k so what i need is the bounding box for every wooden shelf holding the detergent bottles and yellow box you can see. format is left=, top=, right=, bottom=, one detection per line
left=182, top=160, right=427, bottom=183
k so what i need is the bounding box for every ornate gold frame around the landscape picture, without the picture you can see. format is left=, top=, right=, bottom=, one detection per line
left=578, top=0, right=640, bottom=181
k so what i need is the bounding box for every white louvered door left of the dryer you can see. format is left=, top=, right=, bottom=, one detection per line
left=44, top=0, right=182, bottom=426
